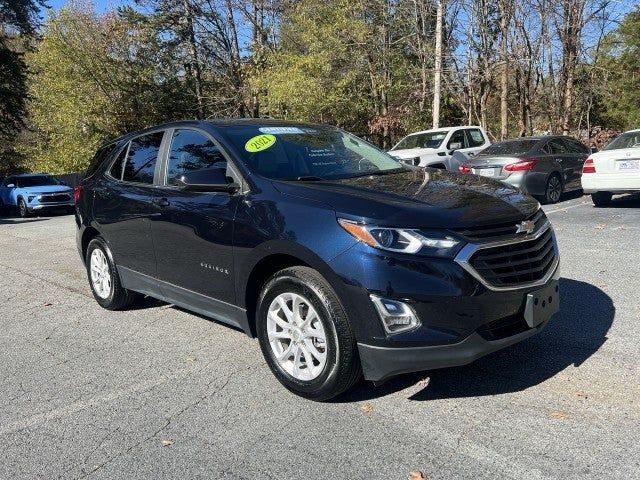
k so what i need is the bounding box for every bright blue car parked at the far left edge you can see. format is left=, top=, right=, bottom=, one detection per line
left=0, top=173, right=75, bottom=218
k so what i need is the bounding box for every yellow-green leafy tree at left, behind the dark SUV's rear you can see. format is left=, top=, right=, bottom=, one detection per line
left=21, top=8, right=188, bottom=173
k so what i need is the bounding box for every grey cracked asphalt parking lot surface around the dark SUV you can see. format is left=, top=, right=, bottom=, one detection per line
left=0, top=196, right=640, bottom=480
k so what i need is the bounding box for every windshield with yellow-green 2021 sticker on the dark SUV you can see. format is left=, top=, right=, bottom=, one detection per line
left=222, top=125, right=405, bottom=180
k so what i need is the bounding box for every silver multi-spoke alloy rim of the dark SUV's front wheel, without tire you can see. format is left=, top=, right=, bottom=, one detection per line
left=267, top=292, right=327, bottom=381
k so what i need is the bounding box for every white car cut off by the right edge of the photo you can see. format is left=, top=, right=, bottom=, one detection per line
left=582, top=130, right=640, bottom=207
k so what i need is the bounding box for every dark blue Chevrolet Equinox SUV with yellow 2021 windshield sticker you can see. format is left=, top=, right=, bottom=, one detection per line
left=75, top=120, right=559, bottom=400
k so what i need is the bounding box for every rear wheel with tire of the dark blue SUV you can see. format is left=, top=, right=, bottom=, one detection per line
left=85, top=237, right=138, bottom=310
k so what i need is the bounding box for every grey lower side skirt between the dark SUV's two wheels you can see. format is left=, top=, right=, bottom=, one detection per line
left=118, top=267, right=253, bottom=337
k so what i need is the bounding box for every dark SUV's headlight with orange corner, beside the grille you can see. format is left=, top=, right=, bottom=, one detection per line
left=338, top=218, right=462, bottom=258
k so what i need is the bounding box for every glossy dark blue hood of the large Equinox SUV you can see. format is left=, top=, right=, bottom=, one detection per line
left=274, top=168, right=539, bottom=228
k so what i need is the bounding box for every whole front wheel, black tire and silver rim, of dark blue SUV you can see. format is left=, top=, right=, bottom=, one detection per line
left=256, top=267, right=362, bottom=401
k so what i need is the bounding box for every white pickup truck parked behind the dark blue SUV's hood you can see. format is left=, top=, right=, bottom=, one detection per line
left=389, top=126, right=491, bottom=172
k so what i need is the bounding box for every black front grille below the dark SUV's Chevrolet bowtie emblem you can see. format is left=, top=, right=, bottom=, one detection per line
left=469, top=228, right=557, bottom=287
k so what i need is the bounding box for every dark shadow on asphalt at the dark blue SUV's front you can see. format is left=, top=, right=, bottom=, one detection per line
left=336, top=278, right=615, bottom=402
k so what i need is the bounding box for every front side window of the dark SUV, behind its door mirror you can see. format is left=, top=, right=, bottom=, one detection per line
left=167, top=130, right=227, bottom=185
